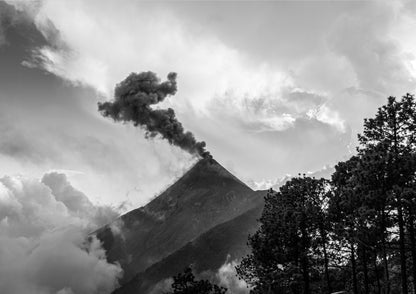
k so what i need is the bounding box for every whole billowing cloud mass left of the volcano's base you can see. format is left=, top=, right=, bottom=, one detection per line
left=0, top=173, right=122, bottom=294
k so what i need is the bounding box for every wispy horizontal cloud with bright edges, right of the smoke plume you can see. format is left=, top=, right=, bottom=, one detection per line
left=208, top=86, right=346, bottom=133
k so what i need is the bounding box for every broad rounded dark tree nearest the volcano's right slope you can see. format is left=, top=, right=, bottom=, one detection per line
left=237, top=177, right=330, bottom=293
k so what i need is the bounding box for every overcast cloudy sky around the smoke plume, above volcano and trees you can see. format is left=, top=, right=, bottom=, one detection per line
left=0, top=0, right=416, bottom=208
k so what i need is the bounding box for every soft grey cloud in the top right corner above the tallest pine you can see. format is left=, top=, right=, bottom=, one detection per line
left=328, top=1, right=415, bottom=97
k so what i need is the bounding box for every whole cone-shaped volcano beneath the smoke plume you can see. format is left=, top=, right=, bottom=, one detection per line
left=96, top=158, right=266, bottom=294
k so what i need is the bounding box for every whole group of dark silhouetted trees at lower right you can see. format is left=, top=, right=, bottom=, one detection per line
left=237, top=94, right=416, bottom=294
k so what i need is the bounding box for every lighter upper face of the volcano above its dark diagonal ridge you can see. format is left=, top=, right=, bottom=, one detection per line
left=97, top=158, right=263, bottom=284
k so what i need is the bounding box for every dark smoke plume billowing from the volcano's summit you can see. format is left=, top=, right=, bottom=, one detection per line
left=98, top=71, right=210, bottom=158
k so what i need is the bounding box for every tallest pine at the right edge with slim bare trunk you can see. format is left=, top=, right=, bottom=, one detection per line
left=358, top=94, right=416, bottom=294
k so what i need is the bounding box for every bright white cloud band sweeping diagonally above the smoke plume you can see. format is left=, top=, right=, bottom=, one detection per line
left=22, top=1, right=348, bottom=131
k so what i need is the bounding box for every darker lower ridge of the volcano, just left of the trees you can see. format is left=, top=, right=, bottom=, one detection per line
left=114, top=191, right=266, bottom=294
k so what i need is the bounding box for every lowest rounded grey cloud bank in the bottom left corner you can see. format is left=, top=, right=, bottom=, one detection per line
left=4, top=228, right=121, bottom=294
